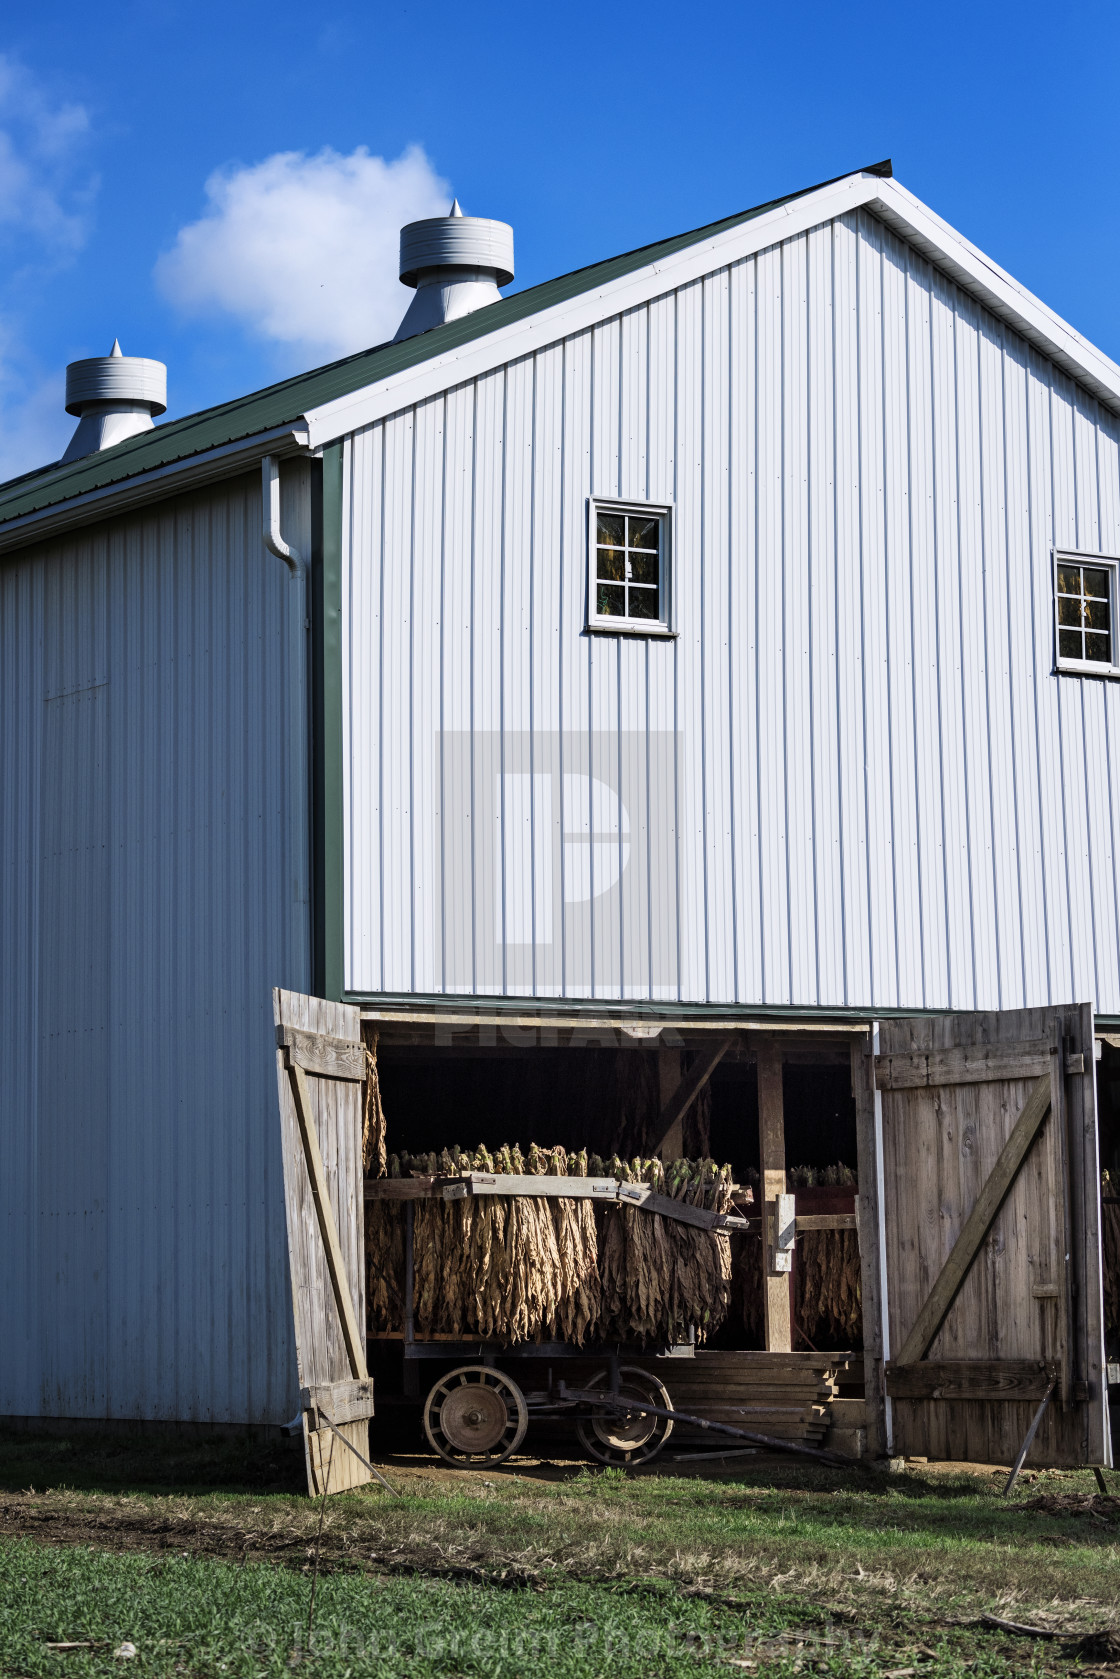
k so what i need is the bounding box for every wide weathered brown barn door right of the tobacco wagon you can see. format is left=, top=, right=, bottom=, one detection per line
left=853, top=1004, right=1110, bottom=1466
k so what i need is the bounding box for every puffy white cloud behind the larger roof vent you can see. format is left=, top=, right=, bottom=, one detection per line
left=156, top=146, right=450, bottom=364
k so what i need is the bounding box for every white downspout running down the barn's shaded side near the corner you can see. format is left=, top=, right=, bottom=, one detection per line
left=260, top=455, right=311, bottom=991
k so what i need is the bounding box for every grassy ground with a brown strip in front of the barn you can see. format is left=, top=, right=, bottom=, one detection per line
left=0, top=1436, right=1120, bottom=1679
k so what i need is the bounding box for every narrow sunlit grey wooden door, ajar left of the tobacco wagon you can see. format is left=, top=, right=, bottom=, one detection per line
left=272, top=991, right=373, bottom=1494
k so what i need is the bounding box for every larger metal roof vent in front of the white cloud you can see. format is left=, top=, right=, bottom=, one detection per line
left=393, top=198, right=514, bottom=344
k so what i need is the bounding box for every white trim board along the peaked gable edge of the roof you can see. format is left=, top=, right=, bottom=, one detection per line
left=306, top=173, right=1120, bottom=448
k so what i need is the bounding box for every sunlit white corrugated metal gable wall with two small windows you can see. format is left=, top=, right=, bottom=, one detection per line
left=344, top=215, right=1120, bottom=1014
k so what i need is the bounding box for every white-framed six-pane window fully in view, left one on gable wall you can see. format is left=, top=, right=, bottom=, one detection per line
left=588, top=495, right=673, bottom=635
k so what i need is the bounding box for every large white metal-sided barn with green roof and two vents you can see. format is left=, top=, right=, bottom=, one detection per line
left=0, top=165, right=1120, bottom=1464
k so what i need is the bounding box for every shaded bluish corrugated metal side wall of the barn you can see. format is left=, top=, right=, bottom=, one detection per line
left=0, top=468, right=311, bottom=1422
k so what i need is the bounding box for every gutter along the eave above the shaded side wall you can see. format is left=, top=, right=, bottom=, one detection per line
left=0, top=416, right=309, bottom=557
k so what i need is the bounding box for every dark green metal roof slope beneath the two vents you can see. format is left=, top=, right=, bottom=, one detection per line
left=0, top=161, right=892, bottom=527
